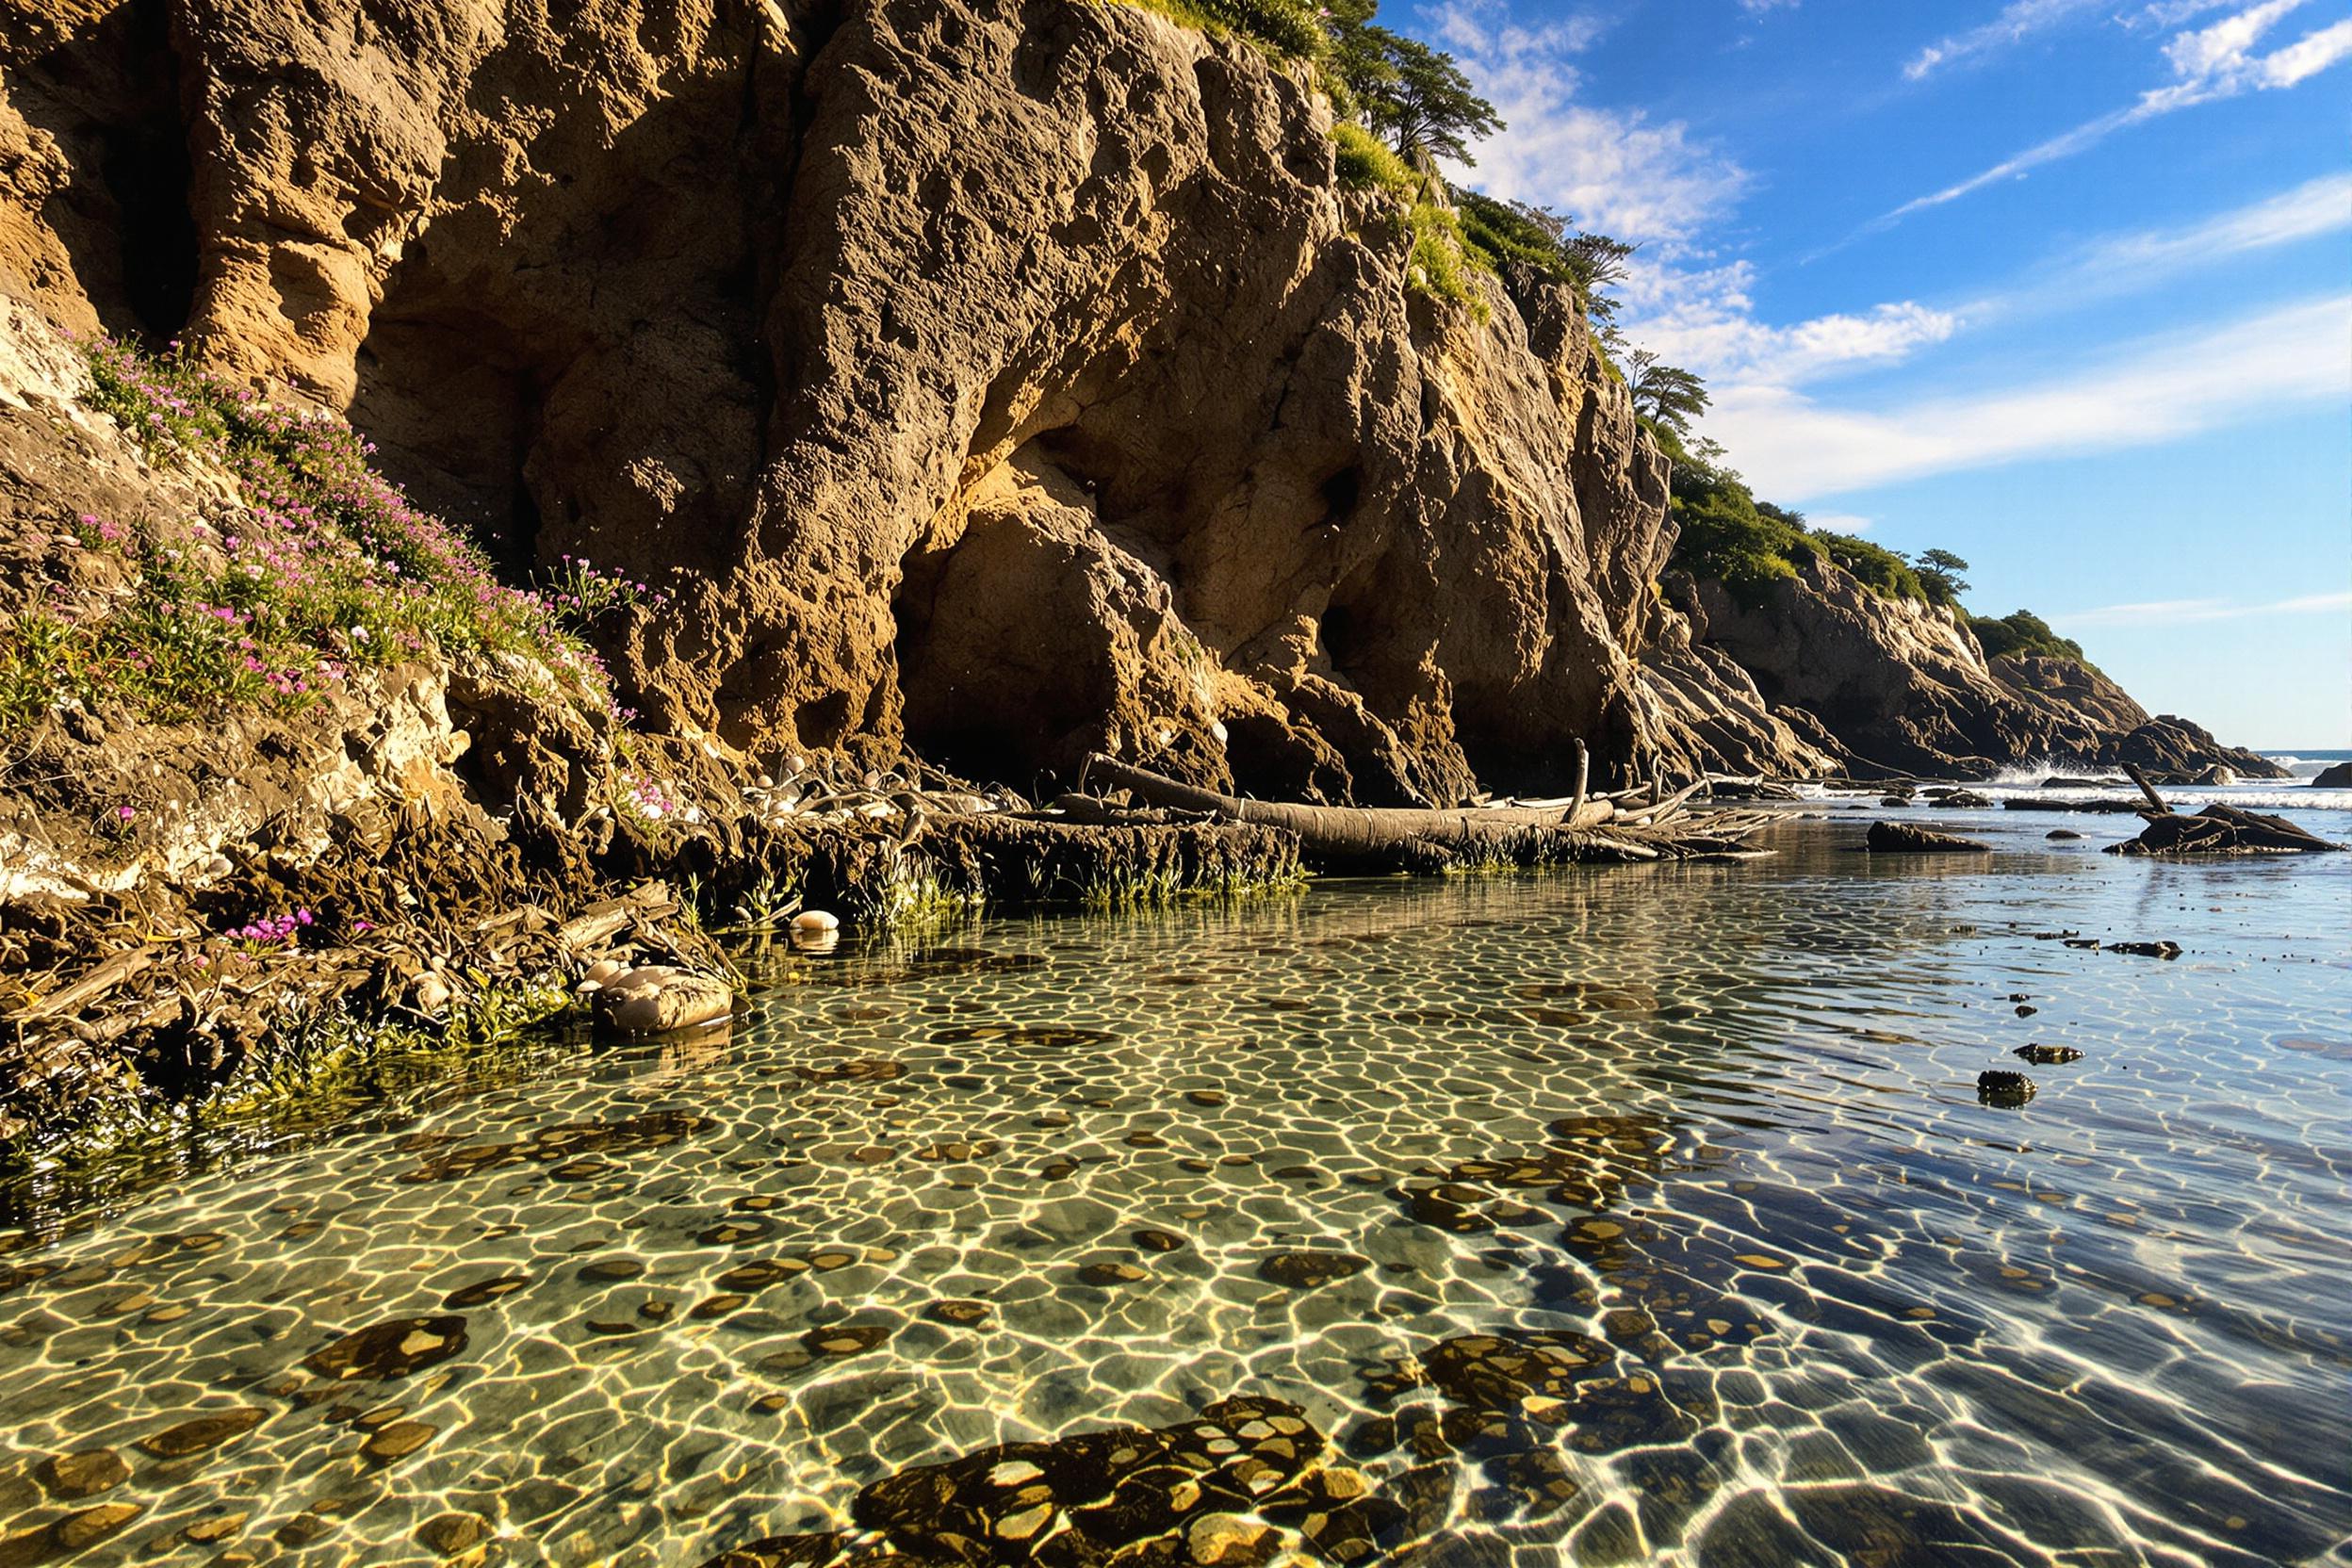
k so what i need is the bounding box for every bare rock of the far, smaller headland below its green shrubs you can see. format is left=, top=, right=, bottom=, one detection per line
left=1691, top=560, right=2284, bottom=780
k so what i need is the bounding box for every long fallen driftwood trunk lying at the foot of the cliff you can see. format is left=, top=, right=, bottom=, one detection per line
left=1080, top=752, right=1616, bottom=865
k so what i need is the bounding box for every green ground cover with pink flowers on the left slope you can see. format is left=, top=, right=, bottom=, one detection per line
left=0, top=338, right=661, bottom=736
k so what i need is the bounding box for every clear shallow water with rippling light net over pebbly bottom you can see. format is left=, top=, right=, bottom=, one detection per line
left=0, top=811, right=2352, bottom=1566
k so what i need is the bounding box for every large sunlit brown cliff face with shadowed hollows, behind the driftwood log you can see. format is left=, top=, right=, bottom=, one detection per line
left=0, top=0, right=1827, bottom=802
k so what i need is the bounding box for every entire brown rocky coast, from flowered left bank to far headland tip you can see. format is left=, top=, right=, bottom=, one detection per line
left=0, top=0, right=2277, bottom=1152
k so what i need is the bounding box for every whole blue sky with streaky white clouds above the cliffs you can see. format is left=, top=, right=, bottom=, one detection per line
left=1411, top=0, right=2352, bottom=747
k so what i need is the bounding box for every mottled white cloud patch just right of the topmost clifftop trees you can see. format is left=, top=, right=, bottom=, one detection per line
left=1430, top=0, right=1748, bottom=253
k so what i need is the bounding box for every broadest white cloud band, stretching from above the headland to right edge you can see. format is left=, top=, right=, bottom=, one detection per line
left=1707, top=294, right=2352, bottom=503
